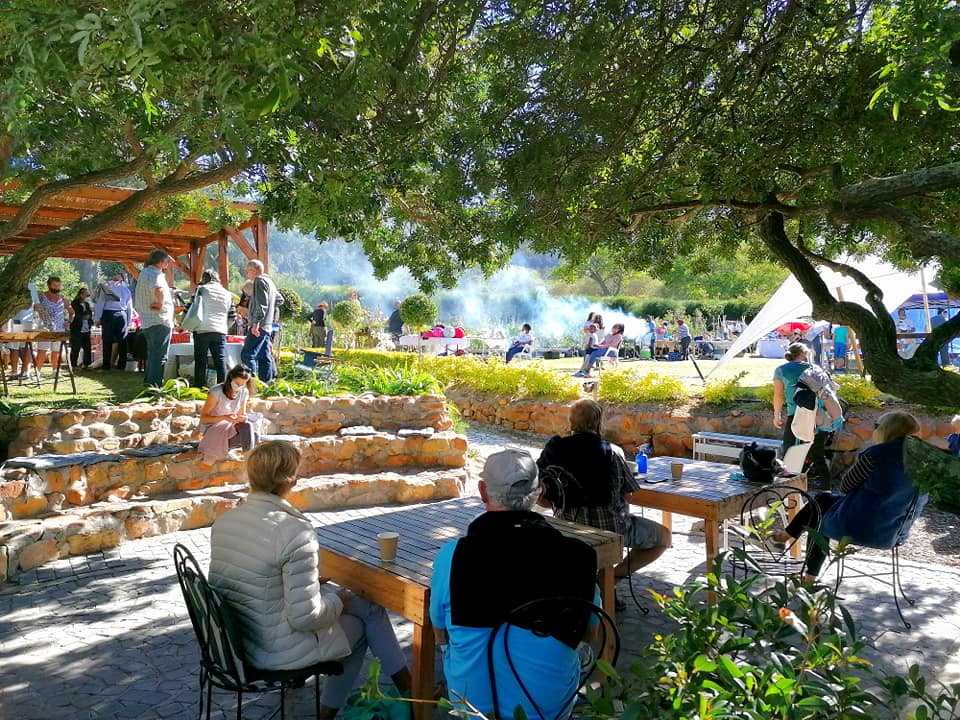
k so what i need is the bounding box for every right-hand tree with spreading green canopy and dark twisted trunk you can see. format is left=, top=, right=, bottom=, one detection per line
left=358, top=0, right=960, bottom=403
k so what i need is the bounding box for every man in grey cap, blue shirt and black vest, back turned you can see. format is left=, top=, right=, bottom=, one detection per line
left=430, top=449, right=599, bottom=720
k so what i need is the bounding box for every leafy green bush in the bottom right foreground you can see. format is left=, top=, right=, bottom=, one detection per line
left=588, top=552, right=960, bottom=720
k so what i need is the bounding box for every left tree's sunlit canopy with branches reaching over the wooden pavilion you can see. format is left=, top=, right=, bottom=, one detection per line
left=0, top=0, right=478, bottom=317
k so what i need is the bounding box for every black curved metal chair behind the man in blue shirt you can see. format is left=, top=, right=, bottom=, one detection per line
left=487, top=596, right=620, bottom=717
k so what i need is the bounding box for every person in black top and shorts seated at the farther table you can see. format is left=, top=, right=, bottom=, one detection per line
left=537, top=398, right=672, bottom=578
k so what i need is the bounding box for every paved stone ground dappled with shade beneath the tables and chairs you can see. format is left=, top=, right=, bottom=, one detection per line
left=0, top=428, right=960, bottom=720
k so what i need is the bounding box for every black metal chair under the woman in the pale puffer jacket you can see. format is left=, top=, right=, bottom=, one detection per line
left=173, top=543, right=343, bottom=720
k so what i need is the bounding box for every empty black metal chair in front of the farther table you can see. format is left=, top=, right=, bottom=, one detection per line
left=727, top=483, right=824, bottom=577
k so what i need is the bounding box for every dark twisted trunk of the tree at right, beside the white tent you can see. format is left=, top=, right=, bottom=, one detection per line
left=760, top=212, right=960, bottom=407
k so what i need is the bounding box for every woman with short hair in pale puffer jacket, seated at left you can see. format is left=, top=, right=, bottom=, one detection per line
left=210, top=441, right=411, bottom=718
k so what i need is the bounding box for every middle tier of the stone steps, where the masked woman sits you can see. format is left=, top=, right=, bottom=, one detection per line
left=0, top=431, right=467, bottom=521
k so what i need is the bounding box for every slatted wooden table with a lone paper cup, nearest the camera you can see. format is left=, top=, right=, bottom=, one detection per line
left=317, top=497, right=623, bottom=720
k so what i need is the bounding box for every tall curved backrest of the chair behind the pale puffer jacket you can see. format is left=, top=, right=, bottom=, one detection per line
left=173, top=543, right=246, bottom=689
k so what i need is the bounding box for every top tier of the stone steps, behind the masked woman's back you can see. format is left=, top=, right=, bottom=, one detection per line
left=7, top=395, right=452, bottom=457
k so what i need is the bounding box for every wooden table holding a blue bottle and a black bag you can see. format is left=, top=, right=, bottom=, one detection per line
left=630, top=456, right=807, bottom=572
